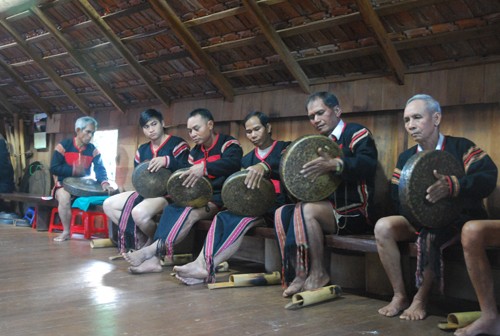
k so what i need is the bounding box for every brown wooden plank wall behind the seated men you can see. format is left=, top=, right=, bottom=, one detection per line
left=34, top=64, right=500, bottom=218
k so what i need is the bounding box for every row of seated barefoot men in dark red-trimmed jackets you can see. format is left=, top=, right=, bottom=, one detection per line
left=47, top=92, right=500, bottom=335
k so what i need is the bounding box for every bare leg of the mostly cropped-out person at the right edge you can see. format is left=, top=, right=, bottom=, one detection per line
left=455, top=220, right=500, bottom=336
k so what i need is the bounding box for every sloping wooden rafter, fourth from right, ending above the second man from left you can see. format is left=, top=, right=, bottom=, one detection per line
left=78, top=0, right=170, bottom=105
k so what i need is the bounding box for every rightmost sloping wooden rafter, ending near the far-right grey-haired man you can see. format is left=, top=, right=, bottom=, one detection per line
left=356, top=0, right=405, bottom=84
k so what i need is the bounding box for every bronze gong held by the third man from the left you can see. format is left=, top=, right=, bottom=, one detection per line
left=167, top=168, right=213, bottom=208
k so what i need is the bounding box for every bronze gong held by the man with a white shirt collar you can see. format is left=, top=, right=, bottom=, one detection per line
left=280, top=135, right=342, bottom=202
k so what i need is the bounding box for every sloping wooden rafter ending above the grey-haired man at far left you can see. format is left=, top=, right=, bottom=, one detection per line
left=0, top=19, right=90, bottom=115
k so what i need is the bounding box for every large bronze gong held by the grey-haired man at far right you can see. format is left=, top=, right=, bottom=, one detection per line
left=398, top=150, right=464, bottom=230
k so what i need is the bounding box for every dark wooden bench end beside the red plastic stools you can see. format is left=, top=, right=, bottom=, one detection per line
left=0, top=192, right=58, bottom=231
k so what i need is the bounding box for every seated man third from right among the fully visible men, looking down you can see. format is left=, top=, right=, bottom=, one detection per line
left=174, top=111, right=290, bottom=285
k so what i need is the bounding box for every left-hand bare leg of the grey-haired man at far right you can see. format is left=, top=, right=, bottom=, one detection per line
left=375, top=216, right=415, bottom=317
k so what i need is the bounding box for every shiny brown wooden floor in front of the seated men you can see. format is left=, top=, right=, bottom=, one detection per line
left=0, top=225, right=460, bottom=336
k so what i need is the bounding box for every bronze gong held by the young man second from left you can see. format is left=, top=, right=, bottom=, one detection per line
left=132, top=161, right=172, bottom=198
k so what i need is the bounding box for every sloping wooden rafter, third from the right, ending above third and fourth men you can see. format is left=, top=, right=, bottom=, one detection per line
left=148, top=0, right=234, bottom=101
